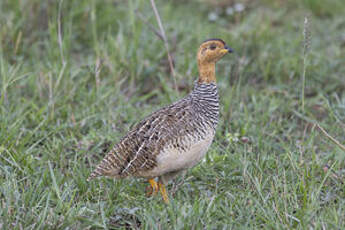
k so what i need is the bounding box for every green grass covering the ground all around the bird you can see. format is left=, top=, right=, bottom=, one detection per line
left=0, top=0, right=345, bottom=229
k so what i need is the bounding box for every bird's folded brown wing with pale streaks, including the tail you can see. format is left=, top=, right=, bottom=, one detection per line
left=88, top=99, right=194, bottom=180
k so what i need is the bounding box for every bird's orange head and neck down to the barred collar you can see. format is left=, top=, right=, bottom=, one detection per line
left=198, top=38, right=233, bottom=83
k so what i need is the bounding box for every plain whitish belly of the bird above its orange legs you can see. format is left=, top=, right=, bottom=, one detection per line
left=143, top=130, right=214, bottom=176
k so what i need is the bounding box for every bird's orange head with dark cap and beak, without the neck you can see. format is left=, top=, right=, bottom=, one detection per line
left=198, top=38, right=233, bottom=65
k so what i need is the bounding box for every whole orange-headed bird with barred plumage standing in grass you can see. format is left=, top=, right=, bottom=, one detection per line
left=87, top=38, right=233, bottom=203
